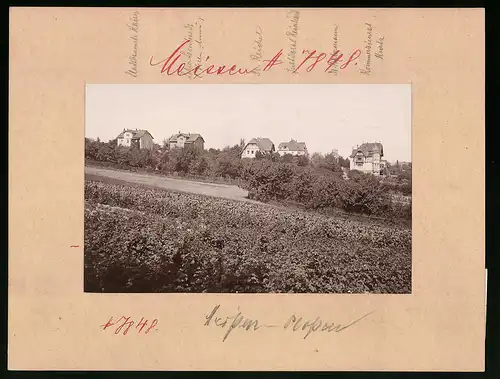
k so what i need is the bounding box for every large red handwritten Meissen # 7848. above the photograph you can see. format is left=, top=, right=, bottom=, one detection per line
left=149, top=40, right=361, bottom=78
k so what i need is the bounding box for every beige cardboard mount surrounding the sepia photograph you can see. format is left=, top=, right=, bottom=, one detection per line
left=8, top=8, right=485, bottom=371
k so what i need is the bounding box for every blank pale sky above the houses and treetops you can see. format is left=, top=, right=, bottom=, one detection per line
left=85, top=84, right=411, bottom=162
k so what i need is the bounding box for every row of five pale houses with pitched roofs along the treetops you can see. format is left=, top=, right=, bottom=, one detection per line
left=117, top=129, right=387, bottom=175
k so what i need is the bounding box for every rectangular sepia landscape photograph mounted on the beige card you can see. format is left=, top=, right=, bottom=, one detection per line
left=84, top=84, right=412, bottom=294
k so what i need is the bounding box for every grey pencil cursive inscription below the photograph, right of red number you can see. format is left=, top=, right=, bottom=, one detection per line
left=204, top=304, right=375, bottom=342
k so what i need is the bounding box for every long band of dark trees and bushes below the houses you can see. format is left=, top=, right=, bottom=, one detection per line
left=85, top=138, right=411, bottom=219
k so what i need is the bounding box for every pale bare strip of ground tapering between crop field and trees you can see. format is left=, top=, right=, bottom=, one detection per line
left=85, top=166, right=254, bottom=201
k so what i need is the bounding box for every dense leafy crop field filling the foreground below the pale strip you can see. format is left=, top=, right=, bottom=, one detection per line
left=85, top=180, right=412, bottom=293
